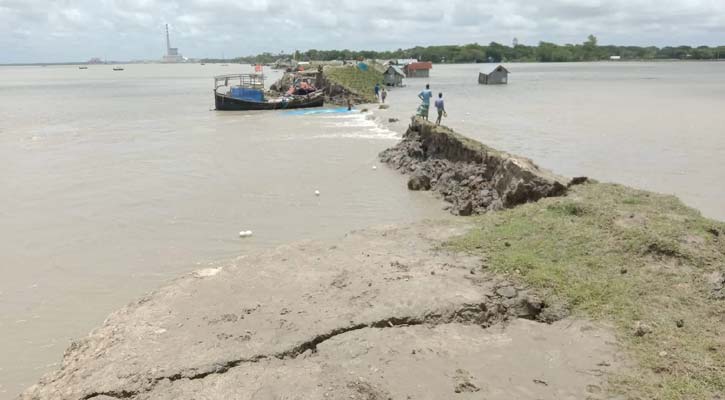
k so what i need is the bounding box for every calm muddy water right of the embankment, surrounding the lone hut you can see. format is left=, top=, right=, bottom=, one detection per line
left=382, top=62, right=725, bottom=220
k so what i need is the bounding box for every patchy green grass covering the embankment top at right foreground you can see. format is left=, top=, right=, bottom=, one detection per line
left=448, top=183, right=725, bottom=400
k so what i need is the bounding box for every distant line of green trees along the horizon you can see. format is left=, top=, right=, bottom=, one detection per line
left=207, top=35, right=725, bottom=64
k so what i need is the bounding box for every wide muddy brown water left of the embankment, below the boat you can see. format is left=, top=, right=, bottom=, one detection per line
left=0, top=64, right=444, bottom=398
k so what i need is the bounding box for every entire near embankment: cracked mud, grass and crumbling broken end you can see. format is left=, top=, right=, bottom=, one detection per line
left=21, top=110, right=725, bottom=400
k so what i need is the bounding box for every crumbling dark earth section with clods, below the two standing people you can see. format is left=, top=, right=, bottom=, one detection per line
left=380, top=117, right=570, bottom=215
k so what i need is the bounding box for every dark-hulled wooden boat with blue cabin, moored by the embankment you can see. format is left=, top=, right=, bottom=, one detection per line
left=214, top=74, right=325, bottom=111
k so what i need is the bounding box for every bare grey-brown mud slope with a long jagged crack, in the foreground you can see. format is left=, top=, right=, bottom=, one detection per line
left=21, top=223, right=617, bottom=400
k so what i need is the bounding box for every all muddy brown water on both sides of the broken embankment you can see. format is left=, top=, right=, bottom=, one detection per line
left=0, top=63, right=725, bottom=398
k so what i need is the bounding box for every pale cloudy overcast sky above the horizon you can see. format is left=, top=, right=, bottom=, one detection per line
left=0, top=0, right=725, bottom=63
